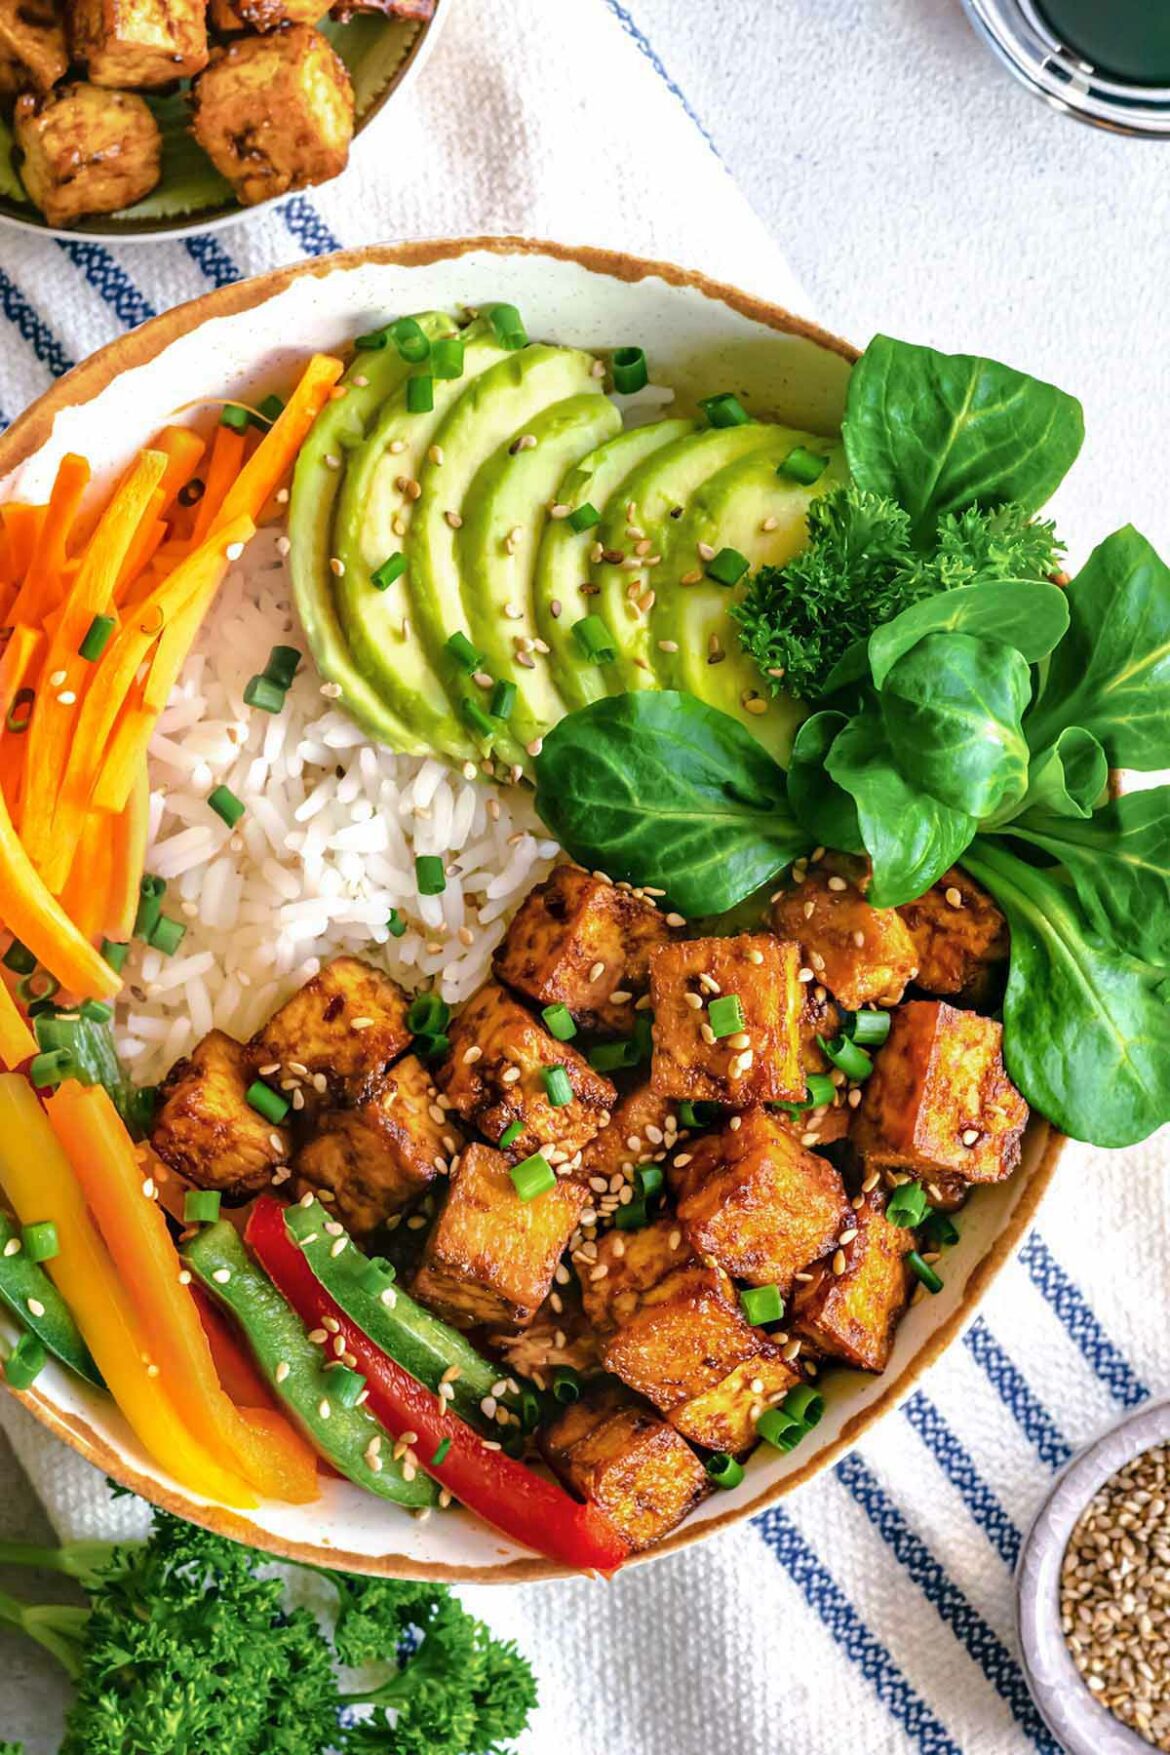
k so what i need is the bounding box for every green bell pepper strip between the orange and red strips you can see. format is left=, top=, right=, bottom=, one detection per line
left=182, top=1218, right=439, bottom=1509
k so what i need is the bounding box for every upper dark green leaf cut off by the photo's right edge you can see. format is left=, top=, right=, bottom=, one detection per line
left=1026, top=525, right=1170, bottom=769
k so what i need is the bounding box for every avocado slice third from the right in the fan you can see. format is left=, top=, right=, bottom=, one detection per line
left=533, top=419, right=695, bottom=709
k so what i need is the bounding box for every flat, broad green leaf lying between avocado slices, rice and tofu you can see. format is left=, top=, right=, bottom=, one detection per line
left=537, top=690, right=812, bottom=914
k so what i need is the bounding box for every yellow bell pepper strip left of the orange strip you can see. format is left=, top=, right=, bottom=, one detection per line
left=0, top=1072, right=258, bottom=1511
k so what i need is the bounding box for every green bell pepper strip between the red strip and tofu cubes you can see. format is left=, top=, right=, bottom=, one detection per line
left=286, top=1200, right=521, bottom=1432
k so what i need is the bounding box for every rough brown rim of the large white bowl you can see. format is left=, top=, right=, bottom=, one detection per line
left=0, top=233, right=1067, bottom=1585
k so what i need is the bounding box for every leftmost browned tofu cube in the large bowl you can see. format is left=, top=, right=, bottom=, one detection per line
left=151, top=1030, right=291, bottom=1199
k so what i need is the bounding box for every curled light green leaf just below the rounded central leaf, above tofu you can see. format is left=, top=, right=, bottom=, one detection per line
left=824, top=713, right=977, bottom=907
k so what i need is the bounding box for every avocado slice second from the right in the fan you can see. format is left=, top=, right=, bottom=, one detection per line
left=589, top=421, right=785, bottom=695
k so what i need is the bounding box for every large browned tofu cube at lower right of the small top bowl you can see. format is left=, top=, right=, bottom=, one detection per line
left=193, top=25, right=354, bottom=207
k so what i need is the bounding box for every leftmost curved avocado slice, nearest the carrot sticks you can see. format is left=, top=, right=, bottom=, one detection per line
left=288, top=311, right=456, bottom=755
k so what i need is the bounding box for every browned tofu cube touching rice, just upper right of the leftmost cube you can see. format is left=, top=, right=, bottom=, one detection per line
left=247, top=956, right=412, bottom=1121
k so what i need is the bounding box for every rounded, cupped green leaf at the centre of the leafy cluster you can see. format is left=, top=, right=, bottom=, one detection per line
left=881, top=634, right=1031, bottom=818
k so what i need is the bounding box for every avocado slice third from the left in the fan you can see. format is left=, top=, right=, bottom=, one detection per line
left=405, top=344, right=600, bottom=765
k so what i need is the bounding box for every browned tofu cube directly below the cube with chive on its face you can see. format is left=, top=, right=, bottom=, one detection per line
left=679, top=1109, right=853, bottom=1297
